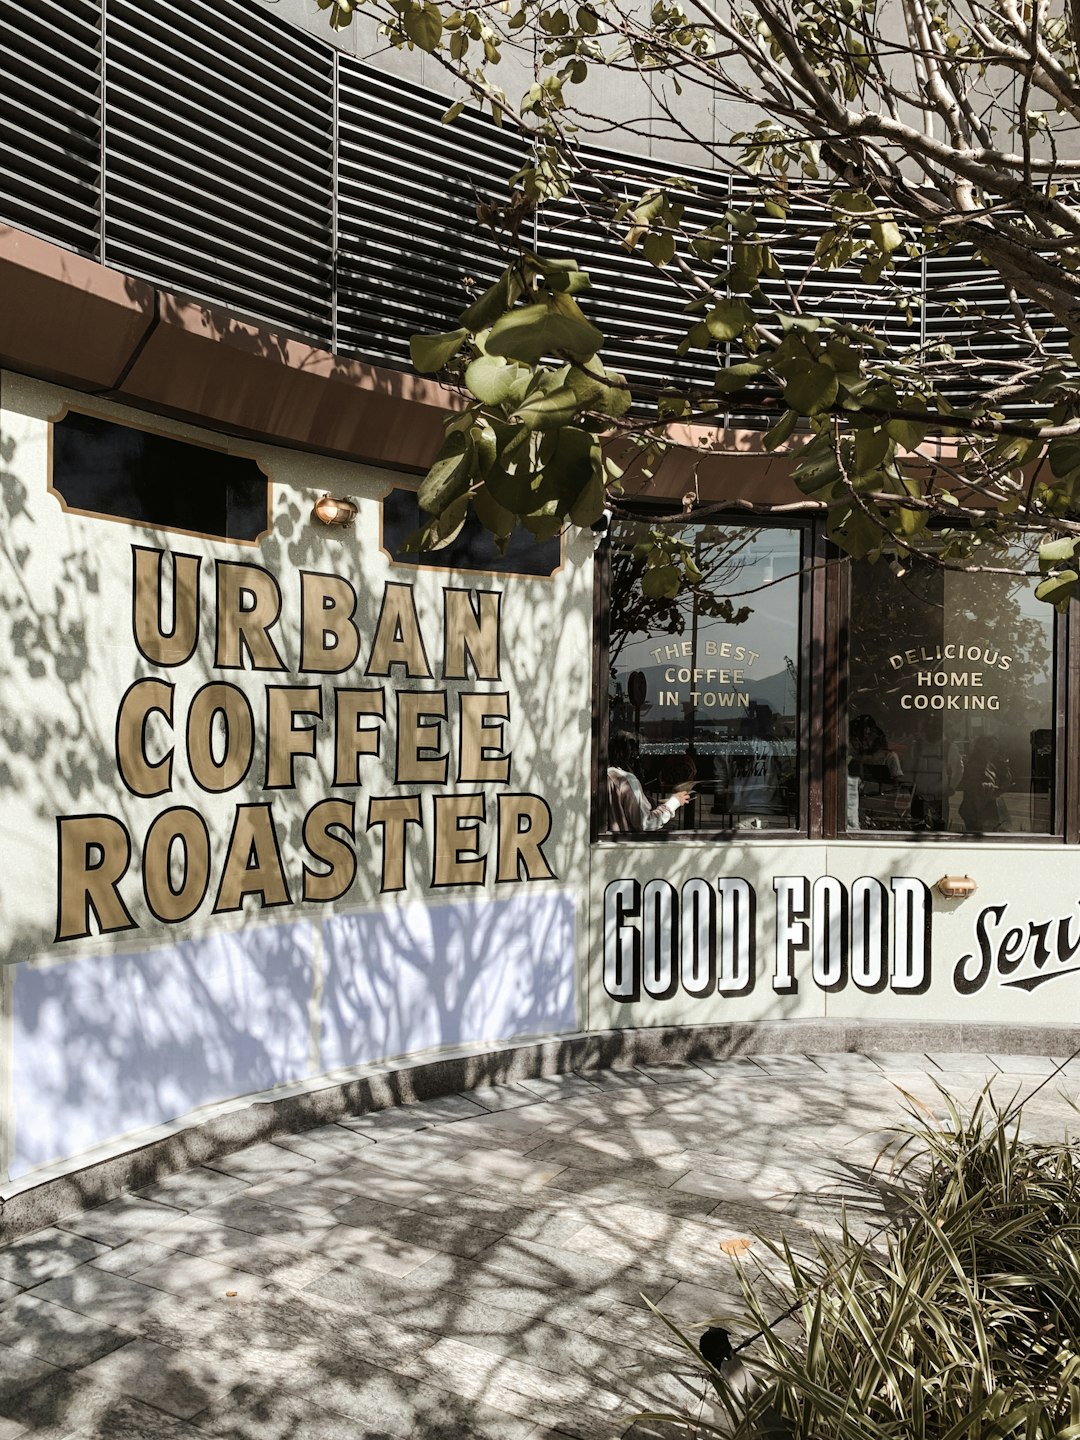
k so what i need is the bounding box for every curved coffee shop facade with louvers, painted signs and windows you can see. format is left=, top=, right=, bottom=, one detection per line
left=0, top=0, right=1080, bottom=1192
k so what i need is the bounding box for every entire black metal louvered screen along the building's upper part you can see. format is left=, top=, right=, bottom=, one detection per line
left=0, top=0, right=1064, bottom=411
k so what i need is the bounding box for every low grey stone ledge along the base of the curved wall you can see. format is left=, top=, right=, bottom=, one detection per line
left=0, top=1020, right=1080, bottom=1240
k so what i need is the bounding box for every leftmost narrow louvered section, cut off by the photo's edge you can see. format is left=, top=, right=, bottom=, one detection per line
left=0, top=0, right=101, bottom=255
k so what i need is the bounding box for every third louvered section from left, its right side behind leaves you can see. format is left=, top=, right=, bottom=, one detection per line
left=337, top=55, right=526, bottom=364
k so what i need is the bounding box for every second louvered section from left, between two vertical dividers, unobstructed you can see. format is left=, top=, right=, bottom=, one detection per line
left=104, top=0, right=334, bottom=341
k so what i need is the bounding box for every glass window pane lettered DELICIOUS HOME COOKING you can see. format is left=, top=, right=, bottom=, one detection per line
left=845, top=562, right=1060, bottom=835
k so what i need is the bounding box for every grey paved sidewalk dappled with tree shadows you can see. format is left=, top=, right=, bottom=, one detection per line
left=0, top=1054, right=1080, bottom=1440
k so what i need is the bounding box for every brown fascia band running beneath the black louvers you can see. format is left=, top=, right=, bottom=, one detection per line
left=0, top=226, right=814, bottom=498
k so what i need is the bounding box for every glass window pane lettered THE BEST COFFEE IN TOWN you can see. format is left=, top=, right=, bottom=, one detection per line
left=608, top=521, right=802, bottom=831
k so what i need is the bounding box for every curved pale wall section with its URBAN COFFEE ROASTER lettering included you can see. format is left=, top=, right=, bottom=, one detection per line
left=0, top=372, right=592, bottom=1178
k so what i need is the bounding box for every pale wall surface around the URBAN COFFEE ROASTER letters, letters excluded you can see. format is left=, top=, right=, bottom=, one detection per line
left=0, top=373, right=592, bottom=1178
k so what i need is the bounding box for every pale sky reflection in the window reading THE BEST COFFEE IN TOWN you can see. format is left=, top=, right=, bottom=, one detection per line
left=612, top=526, right=801, bottom=721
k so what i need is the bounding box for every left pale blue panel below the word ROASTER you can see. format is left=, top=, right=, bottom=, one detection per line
left=10, top=924, right=312, bottom=1176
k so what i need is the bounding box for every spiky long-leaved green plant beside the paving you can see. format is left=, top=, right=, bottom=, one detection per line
left=639, top=1092, right=1080, bottom=1440
